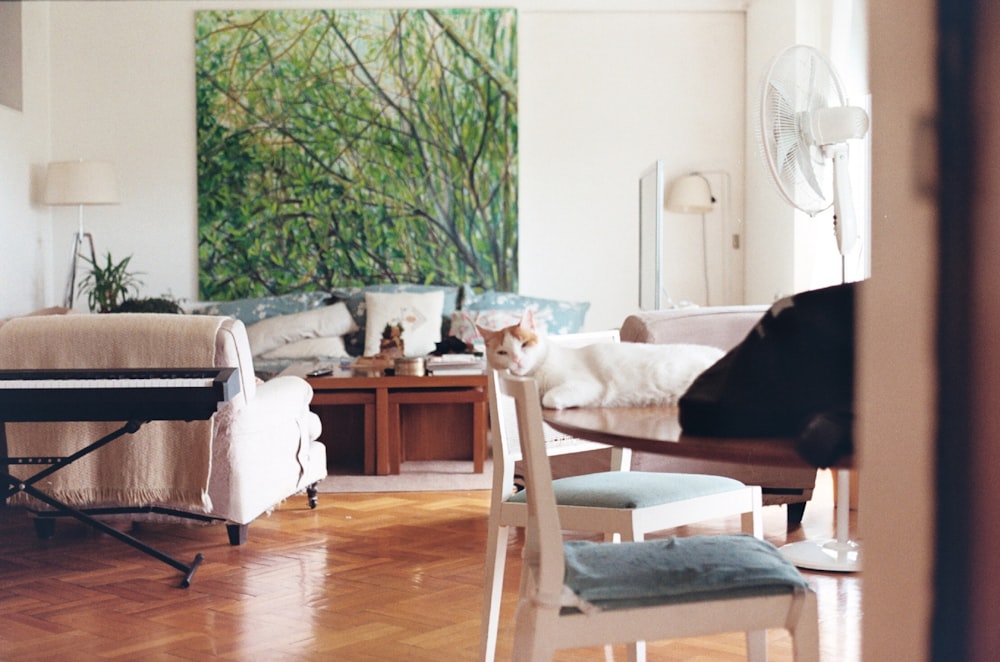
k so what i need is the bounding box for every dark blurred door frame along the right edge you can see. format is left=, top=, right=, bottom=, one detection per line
left=931, top=0, right=1000, bottom=662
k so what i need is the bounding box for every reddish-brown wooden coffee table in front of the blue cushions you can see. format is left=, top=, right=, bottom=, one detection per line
left=282, top=364, right=488, bottom=475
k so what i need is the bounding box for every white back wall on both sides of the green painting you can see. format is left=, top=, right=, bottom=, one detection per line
left=0, top=0, right=745, bottom=328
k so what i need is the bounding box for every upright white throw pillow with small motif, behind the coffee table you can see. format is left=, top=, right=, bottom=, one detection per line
left=365, top=291, right=444, bottom=356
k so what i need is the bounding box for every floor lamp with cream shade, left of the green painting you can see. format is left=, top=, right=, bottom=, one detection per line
left=45, top=161, right=121, bottom=308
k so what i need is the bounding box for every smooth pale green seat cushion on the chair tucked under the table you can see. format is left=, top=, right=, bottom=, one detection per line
left=508, top=471, right=745, bottom=508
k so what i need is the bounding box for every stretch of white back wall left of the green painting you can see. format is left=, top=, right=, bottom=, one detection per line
left=51, top=2, right=197, bottom=312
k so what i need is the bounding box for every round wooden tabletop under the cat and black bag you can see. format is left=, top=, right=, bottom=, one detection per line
left=542, top=406, right=853, bottom=468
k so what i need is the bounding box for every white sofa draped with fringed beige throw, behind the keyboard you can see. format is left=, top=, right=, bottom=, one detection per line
left=0, top=313, right=326, bottom=544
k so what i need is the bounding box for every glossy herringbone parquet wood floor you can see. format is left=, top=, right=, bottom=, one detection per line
left=0, top=474, right=861, bottom=662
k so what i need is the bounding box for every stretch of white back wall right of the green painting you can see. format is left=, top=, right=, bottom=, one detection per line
left=520, top=12, right=744, bottom=320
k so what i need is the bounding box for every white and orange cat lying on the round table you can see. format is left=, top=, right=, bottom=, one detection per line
left=479, top=311, right=724, bottom=409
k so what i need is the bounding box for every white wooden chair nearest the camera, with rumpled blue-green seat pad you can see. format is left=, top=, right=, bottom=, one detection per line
left=499, top=375, right=819, bottom=662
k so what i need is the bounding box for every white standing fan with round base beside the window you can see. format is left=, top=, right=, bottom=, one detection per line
left=757, top=45, right=868, bottom=572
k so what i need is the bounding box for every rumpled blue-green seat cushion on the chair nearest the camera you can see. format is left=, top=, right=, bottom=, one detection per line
left=564, top=534, right=809, bottom=609
